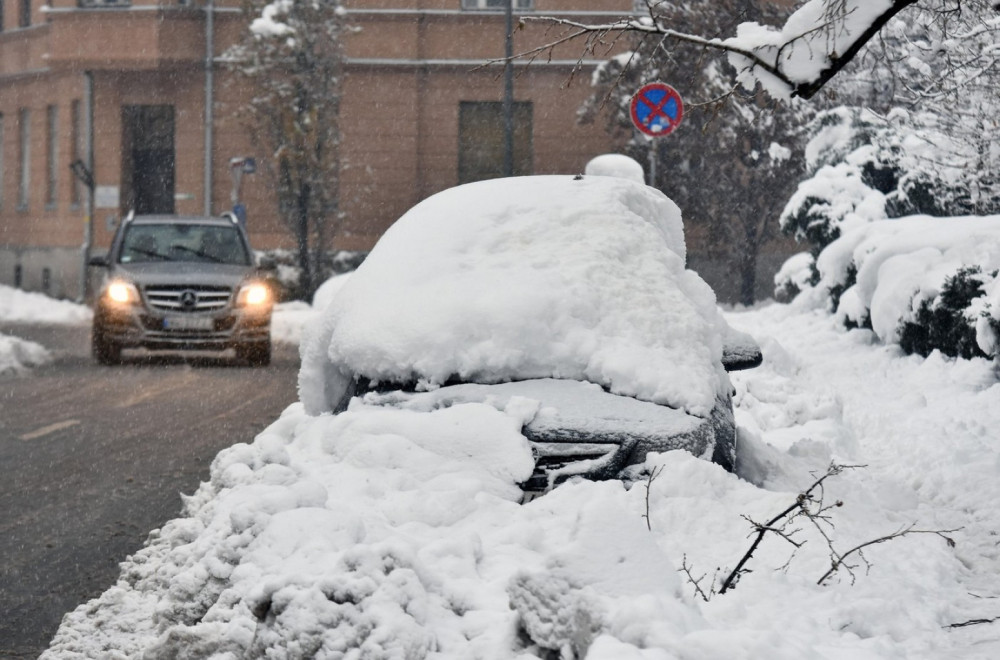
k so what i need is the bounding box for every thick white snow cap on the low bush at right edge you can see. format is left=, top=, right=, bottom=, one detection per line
left=816, top=216, right=1000, bottom=352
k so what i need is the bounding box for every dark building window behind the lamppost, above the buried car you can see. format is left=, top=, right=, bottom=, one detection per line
left=458, top=101, right=533, bottom=183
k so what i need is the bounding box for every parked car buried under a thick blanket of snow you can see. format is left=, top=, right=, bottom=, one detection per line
left=299, top=176, right=760, bottom=491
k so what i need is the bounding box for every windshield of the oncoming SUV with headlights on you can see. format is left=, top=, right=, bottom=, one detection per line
left=118, top=223, right=250, bottom=266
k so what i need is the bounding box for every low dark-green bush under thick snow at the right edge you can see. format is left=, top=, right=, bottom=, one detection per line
left=800, top=216, right=1000, bottom=358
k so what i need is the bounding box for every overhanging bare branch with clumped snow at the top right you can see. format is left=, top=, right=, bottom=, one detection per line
left=516, top=0, right=917, bottom=99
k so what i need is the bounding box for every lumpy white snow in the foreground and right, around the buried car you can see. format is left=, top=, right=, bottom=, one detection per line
left=31, top=305, right=1000, bottom=660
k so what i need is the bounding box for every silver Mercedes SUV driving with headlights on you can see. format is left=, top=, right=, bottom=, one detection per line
left=90, top=216, right=273, bottom=366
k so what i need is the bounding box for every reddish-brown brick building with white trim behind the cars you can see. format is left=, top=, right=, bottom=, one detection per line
left=0, top=0, right=633, bottom=298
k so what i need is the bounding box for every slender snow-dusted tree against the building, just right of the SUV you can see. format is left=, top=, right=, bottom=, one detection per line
left=228, top=0, right=349, bottom=298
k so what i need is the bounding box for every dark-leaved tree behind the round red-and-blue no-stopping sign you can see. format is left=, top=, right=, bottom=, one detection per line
left=581, top=0, right=813, bottom=304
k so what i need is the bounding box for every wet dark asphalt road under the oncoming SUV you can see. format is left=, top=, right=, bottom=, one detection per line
left=0, top=325, right=298, bottom=660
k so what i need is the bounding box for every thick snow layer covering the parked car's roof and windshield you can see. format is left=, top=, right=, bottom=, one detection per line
left=299, top=176, right=728, bottom=416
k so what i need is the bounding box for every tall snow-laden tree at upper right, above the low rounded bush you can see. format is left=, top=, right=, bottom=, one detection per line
left=781, top=1, right=1000, bottom=254
